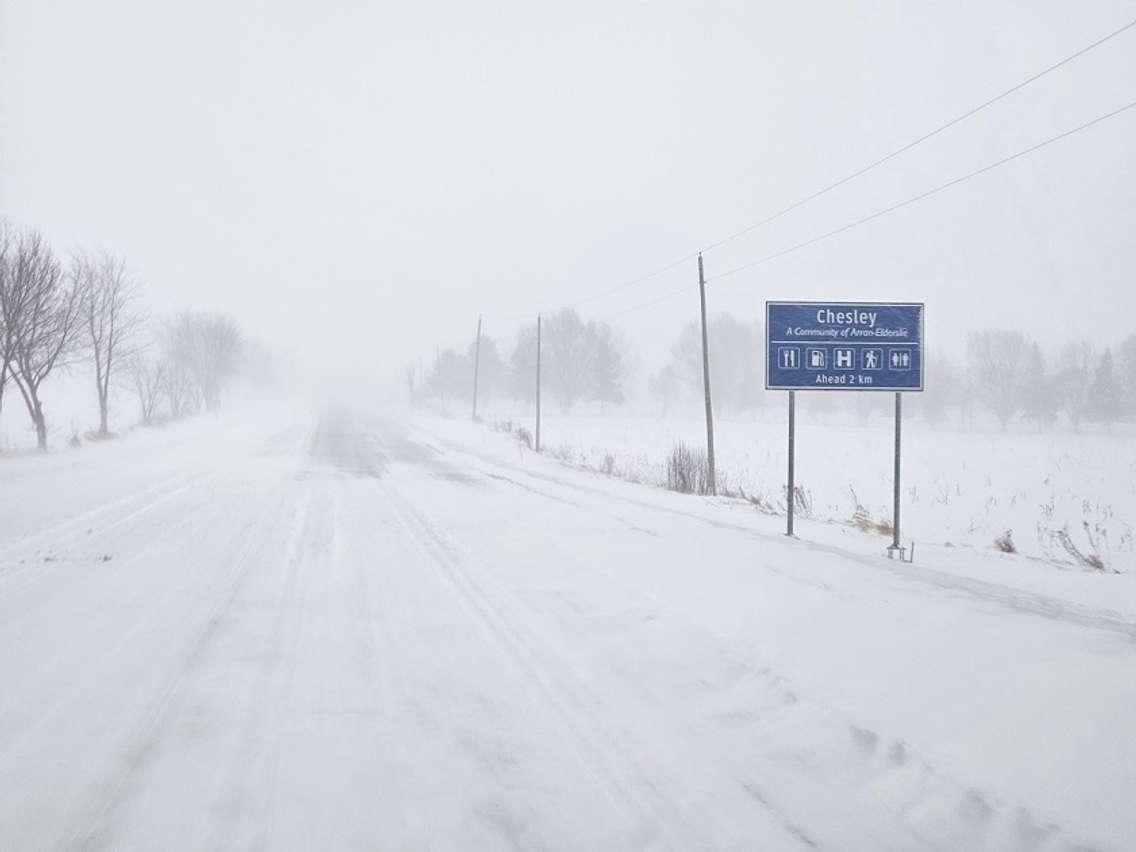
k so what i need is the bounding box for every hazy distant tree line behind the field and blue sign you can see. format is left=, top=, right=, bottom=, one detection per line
left=406, top=308, right=1136, bottom=431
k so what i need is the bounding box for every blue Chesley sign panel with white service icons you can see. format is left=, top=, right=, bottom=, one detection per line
left=766, top=302, right=924, bottom=391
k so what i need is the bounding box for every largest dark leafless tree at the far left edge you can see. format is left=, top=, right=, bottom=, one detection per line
left=0, top=231, right=81, bottom=451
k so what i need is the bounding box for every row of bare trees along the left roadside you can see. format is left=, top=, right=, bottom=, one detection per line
left=0, top=220, right=244, bottom=451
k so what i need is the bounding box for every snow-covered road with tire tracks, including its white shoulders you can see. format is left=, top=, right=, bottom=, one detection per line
left=0, top=408, right=1136, bottom=850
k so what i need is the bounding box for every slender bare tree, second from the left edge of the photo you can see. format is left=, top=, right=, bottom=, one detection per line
left=72, top=252, right=142, bottom=437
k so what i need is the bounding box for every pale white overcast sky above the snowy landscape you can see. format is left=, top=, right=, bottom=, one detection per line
left=0, top=0, right=1136, bottom=379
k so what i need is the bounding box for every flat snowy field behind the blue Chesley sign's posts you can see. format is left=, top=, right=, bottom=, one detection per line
left=485, top=399, right=1136, bottom=571
